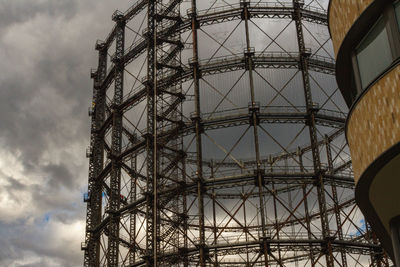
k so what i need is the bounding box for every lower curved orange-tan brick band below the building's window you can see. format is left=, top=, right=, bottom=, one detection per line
left=347, top=66, right=400, bottom=181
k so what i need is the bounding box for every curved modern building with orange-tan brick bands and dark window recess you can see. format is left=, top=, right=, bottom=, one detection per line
left=328, top=0, right=400, bottom=266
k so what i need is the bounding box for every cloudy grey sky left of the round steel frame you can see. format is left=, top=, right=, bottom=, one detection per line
left=0, top=0, right=131, bottom=266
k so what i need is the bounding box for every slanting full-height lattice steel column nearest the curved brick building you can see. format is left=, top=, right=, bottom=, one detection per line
left=293, top=0, right=334, bottom=267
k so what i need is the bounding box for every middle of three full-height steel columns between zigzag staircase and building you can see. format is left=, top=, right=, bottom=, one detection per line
left=240, top=1, right=268, bottom=267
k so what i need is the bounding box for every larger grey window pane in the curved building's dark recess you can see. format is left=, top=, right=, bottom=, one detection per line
left=356, top=19, right=392, bottom=89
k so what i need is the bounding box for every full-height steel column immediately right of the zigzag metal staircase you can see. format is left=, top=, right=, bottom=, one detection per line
left=191, top=0, right=206, bottom=267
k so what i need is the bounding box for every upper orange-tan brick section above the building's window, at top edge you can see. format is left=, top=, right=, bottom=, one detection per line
left=329, top=0, right=373, bottom=55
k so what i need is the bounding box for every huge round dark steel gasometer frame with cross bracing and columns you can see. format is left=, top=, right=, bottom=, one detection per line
left=82, top=0, right=390, bottom=267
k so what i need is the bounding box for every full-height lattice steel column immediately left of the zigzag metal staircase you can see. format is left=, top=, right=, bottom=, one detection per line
left=146, top=0, right=158, bottom=267
